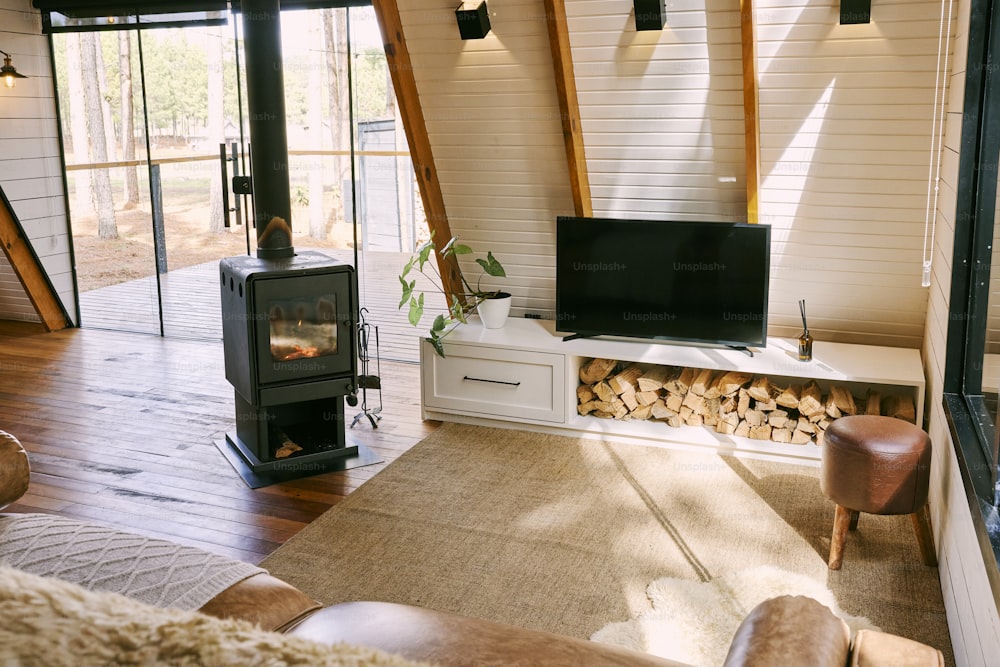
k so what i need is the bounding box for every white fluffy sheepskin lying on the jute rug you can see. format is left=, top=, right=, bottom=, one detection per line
left=591, top=566, right=879, bottom=667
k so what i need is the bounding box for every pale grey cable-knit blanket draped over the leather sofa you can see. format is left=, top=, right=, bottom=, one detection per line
left=0, top=514, right=266, bottom=610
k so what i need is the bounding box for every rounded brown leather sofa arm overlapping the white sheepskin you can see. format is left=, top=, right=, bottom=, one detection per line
left=724, top=595, right=851, bottom=667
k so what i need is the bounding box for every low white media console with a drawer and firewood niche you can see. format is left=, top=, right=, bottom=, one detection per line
left=420, top=318, right=924, bottom=463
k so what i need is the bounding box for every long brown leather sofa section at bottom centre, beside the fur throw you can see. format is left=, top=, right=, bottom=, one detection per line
left=287, top=602, right=688, bottom=667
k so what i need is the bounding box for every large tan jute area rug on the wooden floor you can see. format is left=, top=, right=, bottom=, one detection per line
left=261, top=424, right=953, bottom=664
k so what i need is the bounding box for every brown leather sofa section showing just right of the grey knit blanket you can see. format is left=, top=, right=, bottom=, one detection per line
left=198, top=573, right=320, bottom=631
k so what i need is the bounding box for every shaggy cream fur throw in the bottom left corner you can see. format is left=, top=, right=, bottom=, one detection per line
left=0, top=567, right=426, bottom=667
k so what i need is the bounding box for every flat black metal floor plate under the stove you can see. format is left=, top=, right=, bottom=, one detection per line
left=215, top=433, right=383, bottom=489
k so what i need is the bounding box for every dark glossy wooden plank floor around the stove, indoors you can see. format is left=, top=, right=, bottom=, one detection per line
left=0, top=322, right=437, bottom=563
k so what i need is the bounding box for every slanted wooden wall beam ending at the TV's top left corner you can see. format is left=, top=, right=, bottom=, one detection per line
left=544, top=0, right=594, bottom=217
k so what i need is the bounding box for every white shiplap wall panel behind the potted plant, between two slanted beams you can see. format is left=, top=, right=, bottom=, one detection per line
left=399, top=0, right=573, bottom=311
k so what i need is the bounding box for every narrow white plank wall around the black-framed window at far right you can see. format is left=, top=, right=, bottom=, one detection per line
left=922, top=0, right=1000, bottom=667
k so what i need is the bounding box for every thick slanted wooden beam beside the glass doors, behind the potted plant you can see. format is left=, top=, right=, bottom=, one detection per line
left=372, top=0, right=464, bottom=298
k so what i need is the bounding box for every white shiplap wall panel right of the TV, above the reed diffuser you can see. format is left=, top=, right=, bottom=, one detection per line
left=756, top=0, right=943, bottom=347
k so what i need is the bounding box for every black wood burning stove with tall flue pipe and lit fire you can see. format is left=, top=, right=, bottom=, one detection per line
left=216, top=0, right=379, bottom=487
